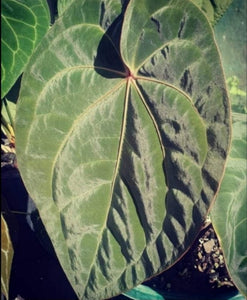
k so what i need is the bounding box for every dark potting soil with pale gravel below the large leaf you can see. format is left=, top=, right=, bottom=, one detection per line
left=144, top=223, right=237, bottom=295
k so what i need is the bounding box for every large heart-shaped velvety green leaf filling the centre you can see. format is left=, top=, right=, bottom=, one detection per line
left=16, top=0, right=230, bottom=300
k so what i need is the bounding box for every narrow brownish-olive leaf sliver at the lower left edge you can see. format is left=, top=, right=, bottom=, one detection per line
left=1, top=214, right=14, bottom=299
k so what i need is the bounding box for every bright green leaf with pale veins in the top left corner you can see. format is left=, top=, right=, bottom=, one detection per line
left=1, top=0, right=50, bottom=98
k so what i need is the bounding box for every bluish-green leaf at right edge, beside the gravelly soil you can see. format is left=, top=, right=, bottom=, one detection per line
left=211, top=113, right=247, bottom=296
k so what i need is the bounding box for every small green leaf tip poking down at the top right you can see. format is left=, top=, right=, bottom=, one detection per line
left=192, top=0, right=233, bottom=25
